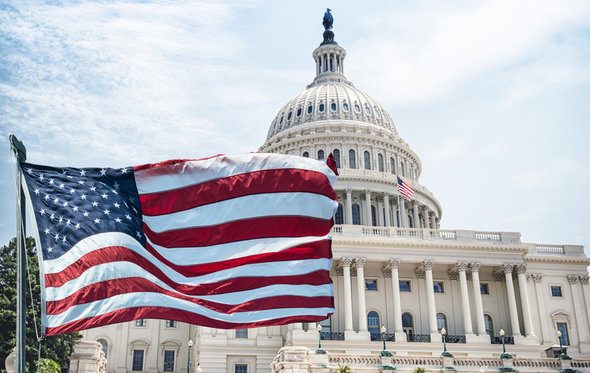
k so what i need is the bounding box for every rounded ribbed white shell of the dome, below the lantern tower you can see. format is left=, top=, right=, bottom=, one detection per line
left=267, top=80, right=399, bottom=139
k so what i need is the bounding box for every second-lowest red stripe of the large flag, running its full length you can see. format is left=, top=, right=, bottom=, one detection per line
left=46, top=277, right=334, bottom=315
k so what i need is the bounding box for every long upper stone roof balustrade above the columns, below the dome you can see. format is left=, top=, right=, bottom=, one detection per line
left=332, top=224, right=520, bottom=244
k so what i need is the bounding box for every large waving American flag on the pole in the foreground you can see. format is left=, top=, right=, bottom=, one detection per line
left=21, top=153, right=337, bottom=335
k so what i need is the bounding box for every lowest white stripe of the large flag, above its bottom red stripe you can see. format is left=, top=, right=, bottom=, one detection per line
left=47, top=293, right=334, bottom=327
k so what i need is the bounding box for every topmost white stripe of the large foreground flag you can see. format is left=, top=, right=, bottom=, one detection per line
left=135, top=153, right=336, bottom=194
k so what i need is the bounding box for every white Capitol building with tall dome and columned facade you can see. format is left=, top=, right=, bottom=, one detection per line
left=72, top=11, right=590, bottom=373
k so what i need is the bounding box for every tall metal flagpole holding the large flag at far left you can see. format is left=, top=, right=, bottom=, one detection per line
left=9, top=135, right=27, bottom=373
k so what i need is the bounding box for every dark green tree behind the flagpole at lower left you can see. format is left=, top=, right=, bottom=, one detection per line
left=0, top=238, right=81, bottom=372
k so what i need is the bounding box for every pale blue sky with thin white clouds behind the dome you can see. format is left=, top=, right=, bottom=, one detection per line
left=0, top=0, right=590, bottom=253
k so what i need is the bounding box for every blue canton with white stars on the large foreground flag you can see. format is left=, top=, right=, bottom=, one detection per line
left=21, top=162, right=145, bottom=259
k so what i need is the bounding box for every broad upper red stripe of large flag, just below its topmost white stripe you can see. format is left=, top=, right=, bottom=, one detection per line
left=139, top=168, right=336, bottom=216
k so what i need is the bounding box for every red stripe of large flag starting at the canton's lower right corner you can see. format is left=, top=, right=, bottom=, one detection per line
left=143, top=216, right=333, bottom=248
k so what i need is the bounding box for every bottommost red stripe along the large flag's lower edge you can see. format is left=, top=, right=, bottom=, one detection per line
left=45, top=307, right=332, bottom=336
